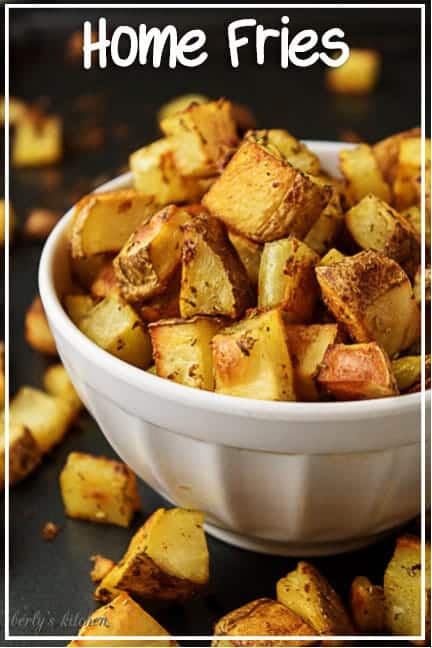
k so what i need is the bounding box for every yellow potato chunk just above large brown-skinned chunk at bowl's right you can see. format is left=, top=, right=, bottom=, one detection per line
left=345, top=194, right=420, bottom=276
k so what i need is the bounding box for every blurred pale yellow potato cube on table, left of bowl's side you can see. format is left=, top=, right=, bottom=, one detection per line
left=9, top=387, right=76, bottom=454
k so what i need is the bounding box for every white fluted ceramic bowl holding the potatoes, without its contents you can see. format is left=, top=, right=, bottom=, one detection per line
left=39, top=142, right=430, bottom=556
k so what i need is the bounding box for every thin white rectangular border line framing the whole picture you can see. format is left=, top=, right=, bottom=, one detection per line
left=4, top=3, right=426, bottom=645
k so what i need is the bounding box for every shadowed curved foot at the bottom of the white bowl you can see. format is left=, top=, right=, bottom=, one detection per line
left=204, top=522, right=394, bottom=558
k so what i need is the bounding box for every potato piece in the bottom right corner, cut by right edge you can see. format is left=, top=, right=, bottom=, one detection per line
left=384, top=535, right=431, bottom=646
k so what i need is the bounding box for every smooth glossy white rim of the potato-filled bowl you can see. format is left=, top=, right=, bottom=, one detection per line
left=39, top=141, right=431, bottom=421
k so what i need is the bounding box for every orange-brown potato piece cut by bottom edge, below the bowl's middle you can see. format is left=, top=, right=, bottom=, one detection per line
left=212, top=598, right=315, bottom=648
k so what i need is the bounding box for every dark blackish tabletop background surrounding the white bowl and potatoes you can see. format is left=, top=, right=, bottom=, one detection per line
left=1, top=3, right=430, bottom=645
